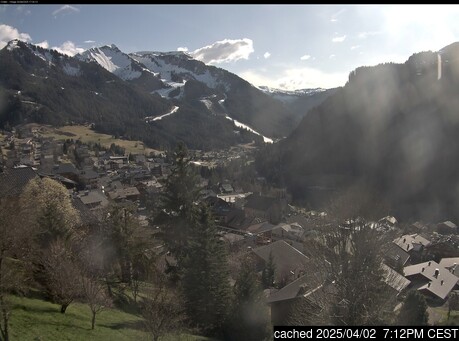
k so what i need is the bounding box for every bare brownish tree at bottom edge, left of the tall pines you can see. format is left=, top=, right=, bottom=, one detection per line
left=141, top=272, right=186, bottom=341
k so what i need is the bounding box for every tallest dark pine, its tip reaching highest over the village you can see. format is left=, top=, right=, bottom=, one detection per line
left=156, top=143, right=200, bottom=266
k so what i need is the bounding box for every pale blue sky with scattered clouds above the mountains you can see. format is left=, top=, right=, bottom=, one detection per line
left=0, top=4, right=459, bottom=90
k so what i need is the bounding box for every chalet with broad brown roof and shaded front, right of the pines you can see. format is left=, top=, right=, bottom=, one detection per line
left=252, top=240, right=310, bottom=284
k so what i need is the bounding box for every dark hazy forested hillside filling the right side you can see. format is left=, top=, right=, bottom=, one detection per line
left=258, top=43, right=459, bottom=220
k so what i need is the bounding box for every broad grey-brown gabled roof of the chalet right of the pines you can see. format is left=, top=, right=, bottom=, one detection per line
left=253, top=240, right=310, bottom=276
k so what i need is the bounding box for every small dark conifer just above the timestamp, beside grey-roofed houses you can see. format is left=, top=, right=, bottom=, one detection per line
left=397, top=290, right=429, bottom=326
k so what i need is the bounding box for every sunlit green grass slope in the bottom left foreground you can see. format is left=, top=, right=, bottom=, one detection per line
left=10, top=296, right=216, bottom=341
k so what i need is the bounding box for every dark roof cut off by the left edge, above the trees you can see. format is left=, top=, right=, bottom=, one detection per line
left=0, top=167, right=38, bottom=197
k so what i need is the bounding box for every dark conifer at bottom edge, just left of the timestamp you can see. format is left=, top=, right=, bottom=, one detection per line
left=229, top=255, right=271, bottom=341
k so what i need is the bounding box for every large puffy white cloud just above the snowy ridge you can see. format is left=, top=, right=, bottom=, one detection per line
left=191, top=38, right=254, bottom=64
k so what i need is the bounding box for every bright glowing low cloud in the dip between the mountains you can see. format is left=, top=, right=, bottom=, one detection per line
left=238, top=68, right=348, bottom=90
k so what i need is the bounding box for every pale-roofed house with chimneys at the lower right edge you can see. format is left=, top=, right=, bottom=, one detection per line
left=403, top=261, right=459, bottom=302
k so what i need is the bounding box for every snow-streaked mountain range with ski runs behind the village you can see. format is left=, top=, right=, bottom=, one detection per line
left=0, top=40, right=328, bottom=149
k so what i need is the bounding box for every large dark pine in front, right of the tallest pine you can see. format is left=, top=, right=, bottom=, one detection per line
left=182, top=206, right=231, bottom=336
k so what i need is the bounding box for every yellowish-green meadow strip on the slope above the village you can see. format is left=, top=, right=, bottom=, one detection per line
left=33, top=124, right=164, bottom=155
